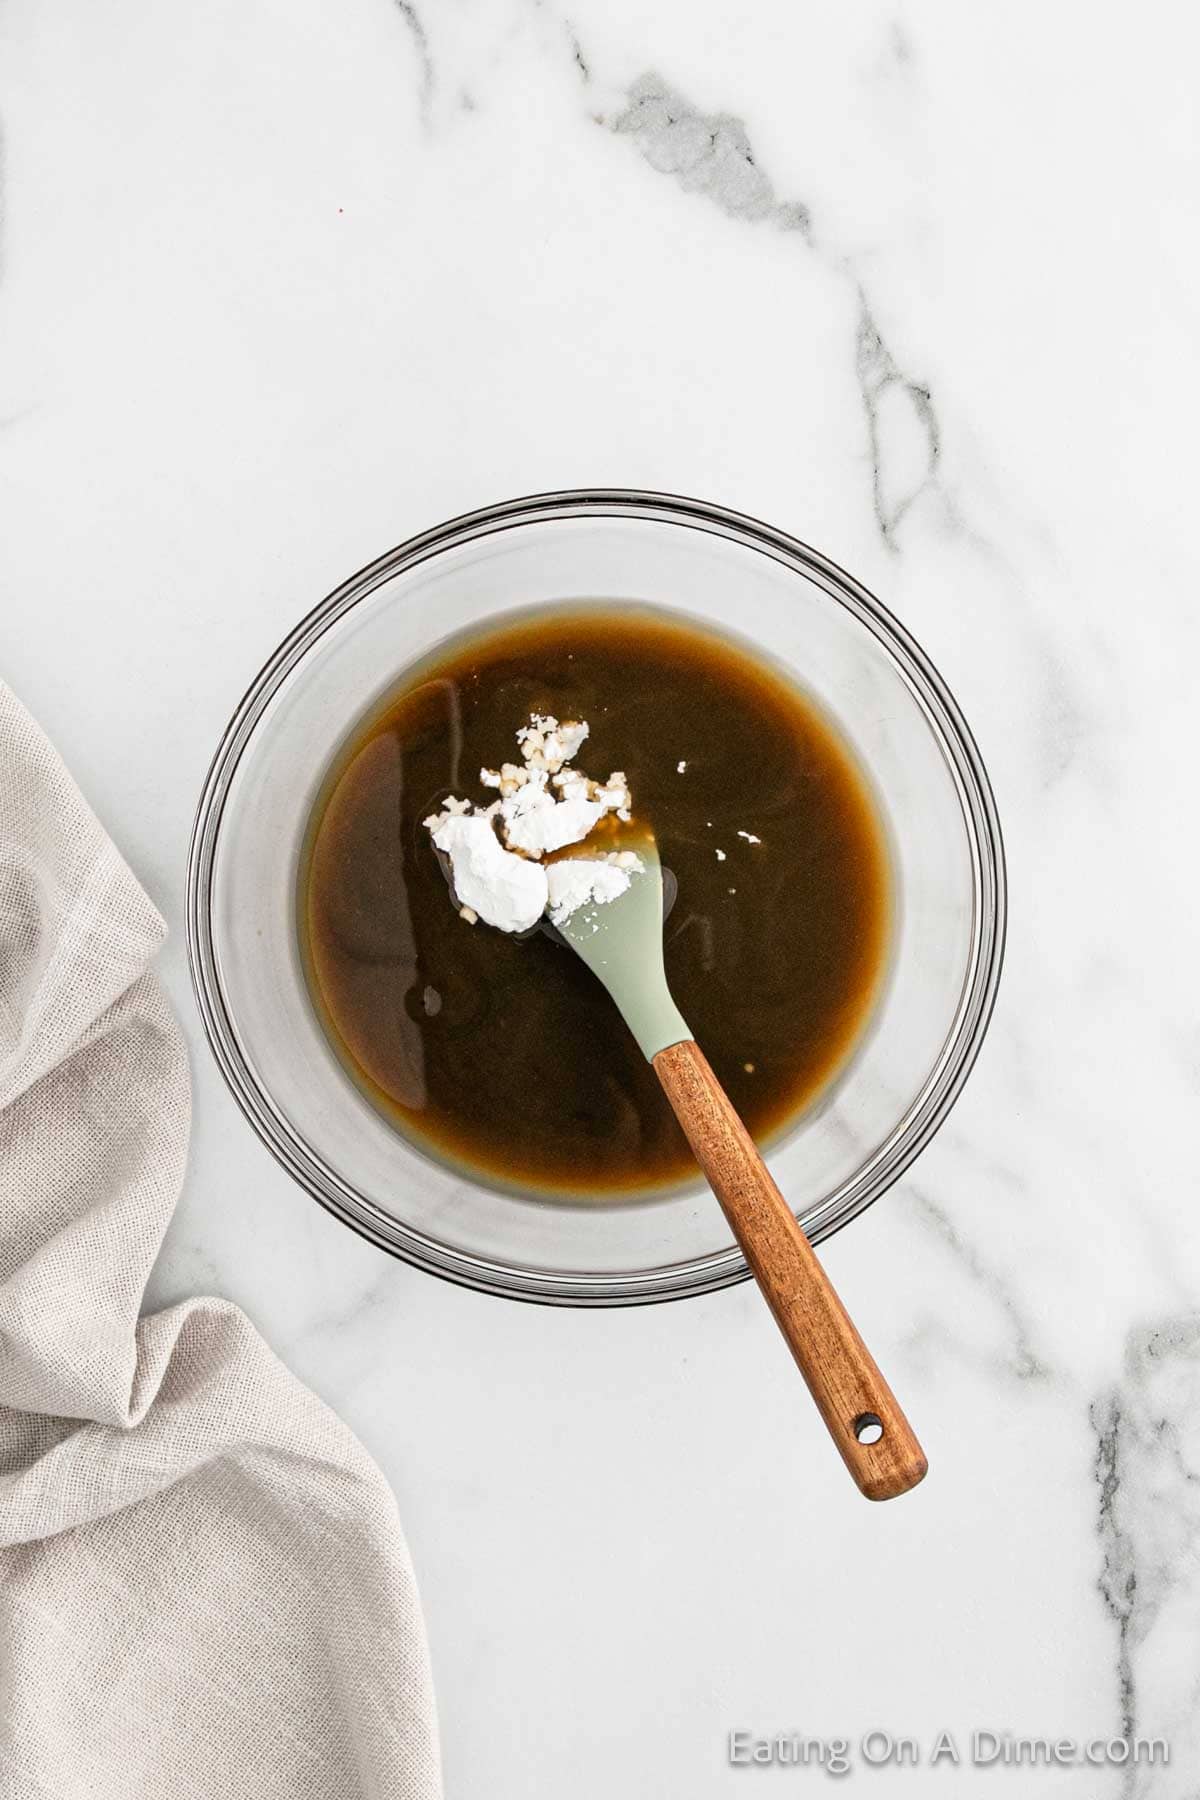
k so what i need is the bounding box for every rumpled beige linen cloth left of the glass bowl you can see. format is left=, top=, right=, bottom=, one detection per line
left=0, top=684, right=441, bottom=1800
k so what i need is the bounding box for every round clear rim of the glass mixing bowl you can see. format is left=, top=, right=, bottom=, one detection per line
left=185, top=488, right=1007, bottom=1307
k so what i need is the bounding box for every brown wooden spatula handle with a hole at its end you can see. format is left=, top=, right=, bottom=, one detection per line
left=653, top=1039, right=928, bottom=1499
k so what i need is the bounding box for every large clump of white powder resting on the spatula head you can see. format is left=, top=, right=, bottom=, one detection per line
left=425, top=713, right=642, bottom=931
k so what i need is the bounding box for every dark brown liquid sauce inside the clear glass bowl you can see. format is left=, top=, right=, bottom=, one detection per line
left=299, top=607, right=889, bottom=1199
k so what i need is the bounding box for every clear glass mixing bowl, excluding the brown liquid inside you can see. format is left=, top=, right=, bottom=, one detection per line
left=187, top=490, right=1006, bottom=1305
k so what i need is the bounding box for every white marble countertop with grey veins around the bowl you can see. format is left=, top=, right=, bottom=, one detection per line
left=0, top=0, right=1200, bottom=1800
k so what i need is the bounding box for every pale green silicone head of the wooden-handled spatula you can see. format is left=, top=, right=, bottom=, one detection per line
left=556, top=830, right=693, bottom=1062
